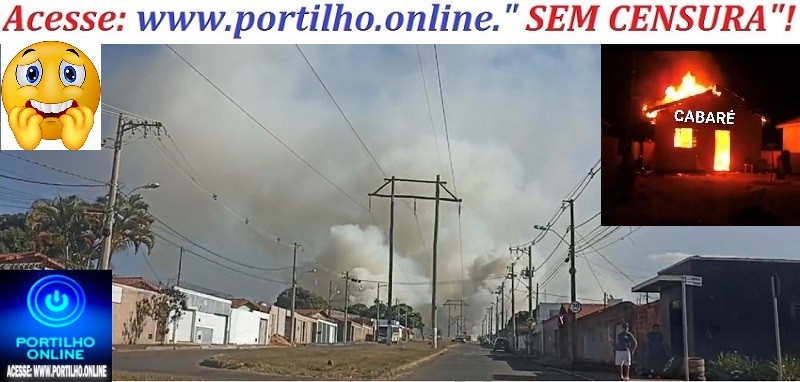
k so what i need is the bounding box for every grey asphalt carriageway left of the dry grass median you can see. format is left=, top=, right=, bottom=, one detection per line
left=111, top=349, right=282, bottom=381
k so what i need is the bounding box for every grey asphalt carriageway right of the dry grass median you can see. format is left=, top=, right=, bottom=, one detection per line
left=398, top=344, right=592, bottom=381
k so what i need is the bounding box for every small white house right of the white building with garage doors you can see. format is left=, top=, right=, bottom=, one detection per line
left=229, top=299, right=270, bottom=345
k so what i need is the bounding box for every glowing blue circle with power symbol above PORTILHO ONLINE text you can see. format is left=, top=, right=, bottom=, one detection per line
left=28, top=275, right=86, bottom=328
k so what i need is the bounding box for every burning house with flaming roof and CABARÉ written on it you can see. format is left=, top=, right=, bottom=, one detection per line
left=642, top=73, right=766, bottom=173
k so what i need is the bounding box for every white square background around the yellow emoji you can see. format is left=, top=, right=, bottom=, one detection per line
left=0, top=40, right=103, bottom=151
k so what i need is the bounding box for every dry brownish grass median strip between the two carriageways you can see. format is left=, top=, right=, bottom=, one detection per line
left=206, top=342, right=451, bottom=380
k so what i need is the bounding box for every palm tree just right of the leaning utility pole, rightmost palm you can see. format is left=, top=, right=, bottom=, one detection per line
left=97, top=194, right=155, bottom=255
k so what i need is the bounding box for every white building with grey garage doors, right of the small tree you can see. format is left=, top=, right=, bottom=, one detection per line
left=170, top=287, right=231, bottom=345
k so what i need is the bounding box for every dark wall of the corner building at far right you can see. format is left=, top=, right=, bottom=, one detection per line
left=660, top=259, right=800, bottom=359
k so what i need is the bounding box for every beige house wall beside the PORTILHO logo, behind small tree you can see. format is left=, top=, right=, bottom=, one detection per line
left=111, top=284, right=159, bottom=345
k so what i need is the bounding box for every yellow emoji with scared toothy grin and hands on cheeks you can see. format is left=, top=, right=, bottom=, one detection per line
left=0, top=41, right=100, bottom=150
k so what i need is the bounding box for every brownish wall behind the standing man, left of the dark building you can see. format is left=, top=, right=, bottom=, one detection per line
left=576, top=302, right=636, bottom=363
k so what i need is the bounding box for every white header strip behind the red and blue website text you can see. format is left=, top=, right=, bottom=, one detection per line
left=0, top=0, right=800, bottom=44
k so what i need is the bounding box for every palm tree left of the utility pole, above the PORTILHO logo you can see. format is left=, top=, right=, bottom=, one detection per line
left=25, top=195, right=97, bottom=267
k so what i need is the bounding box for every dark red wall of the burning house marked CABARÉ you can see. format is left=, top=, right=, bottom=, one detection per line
left=654, top=93, right=762, bottom=172
